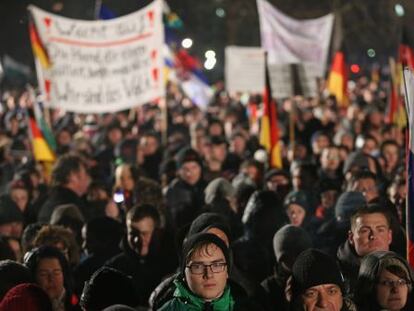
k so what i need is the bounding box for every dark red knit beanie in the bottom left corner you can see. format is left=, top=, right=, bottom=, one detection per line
left=0, top=283, right=52, bottom=311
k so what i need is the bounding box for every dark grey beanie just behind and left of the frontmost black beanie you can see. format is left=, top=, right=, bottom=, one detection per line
left=273, top=225, right=312, bottom=263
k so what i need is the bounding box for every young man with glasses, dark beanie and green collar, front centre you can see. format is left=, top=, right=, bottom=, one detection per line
left=160, top=233, right=237, bottom=311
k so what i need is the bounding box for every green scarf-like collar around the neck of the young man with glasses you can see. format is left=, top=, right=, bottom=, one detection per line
left=174, top=280, right=234, bottom=311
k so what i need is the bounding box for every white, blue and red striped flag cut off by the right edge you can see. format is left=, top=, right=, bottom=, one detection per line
left=404, top=68, right=414, bottom=268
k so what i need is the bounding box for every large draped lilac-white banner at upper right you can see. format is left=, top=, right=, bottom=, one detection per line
left=257, top=0, right=334, bottom=97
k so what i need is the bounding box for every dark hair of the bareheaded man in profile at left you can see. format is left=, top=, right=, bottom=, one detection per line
left=52, top=153, right=86, bottom=186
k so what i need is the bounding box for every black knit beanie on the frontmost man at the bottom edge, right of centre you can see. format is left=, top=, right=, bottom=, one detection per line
left=292, top=248, right=344, bottom=298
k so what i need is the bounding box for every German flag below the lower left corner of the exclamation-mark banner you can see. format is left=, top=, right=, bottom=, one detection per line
left=27, top=111, right=56, bottom=162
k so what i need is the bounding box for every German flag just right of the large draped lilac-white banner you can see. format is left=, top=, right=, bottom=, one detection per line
left=328, top=50, right=348, bottom=108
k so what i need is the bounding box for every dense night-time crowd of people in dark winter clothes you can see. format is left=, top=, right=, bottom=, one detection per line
left=0, top=72, right=413, bottom=311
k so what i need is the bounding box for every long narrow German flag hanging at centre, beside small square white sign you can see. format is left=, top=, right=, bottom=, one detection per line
left=260, top=62, right=282, bottom=168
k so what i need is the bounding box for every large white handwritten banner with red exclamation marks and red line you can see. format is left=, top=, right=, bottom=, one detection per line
left=29, top=0, right=165, bottom=113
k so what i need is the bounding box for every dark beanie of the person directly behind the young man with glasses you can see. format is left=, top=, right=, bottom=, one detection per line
left=187, top=213, right=231, bottom=243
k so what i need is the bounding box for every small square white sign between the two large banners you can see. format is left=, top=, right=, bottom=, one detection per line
left=225, top=46, right=265, bottom=93
